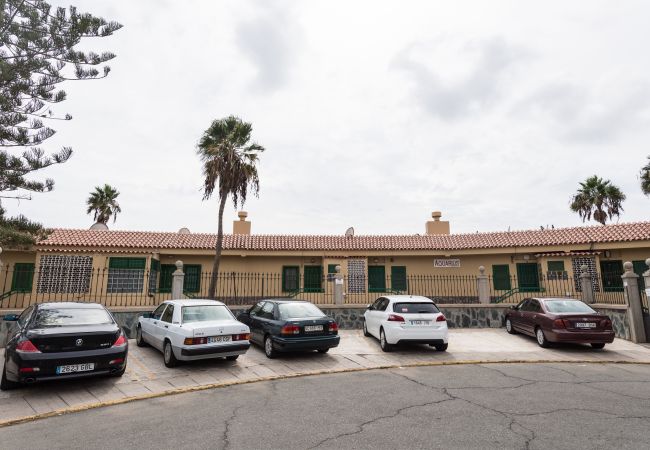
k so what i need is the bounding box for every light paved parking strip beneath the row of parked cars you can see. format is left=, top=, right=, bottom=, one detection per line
left=0, top=329, right=650, bottom=426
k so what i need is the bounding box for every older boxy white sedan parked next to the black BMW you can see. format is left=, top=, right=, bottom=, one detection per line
left=136, top=300, right=251, bottom=367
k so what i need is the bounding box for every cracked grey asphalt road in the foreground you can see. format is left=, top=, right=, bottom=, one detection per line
left=0, top=364, right=650, bottom=449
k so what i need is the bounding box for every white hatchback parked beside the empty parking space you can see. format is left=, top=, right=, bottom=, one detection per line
left=363, top=295, right=448, bottom=352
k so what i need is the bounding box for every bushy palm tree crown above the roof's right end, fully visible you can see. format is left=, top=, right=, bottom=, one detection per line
left=571, top=175, right=625, bottom=225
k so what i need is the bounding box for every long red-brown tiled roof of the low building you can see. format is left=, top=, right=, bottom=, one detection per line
left=37, top=222, right=650, bottom=251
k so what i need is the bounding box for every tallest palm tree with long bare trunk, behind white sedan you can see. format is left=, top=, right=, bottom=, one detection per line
left=197, top=116, right=264, bottom=298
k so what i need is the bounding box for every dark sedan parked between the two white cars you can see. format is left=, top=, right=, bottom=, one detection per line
left=237, top=299, right=340, bottom=358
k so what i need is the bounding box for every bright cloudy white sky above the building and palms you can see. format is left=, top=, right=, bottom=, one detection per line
left=3, top=0, right=650, bottom=234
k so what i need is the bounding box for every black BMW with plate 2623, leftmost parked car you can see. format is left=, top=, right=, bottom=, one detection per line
left=0, top=303, right=129, bottom=390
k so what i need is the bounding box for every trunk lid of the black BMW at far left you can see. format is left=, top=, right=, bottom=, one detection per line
left=27, top=324, right=120, bottom=353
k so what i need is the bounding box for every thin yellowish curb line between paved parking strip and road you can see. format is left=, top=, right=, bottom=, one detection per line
left=0, top=359, right=650, bottom=428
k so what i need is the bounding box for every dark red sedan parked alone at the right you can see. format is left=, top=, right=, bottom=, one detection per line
left=506, top=298, right=614, bottom=348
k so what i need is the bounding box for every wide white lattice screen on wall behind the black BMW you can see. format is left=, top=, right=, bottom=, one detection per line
left=36, top=255, right=93, bottom=294
